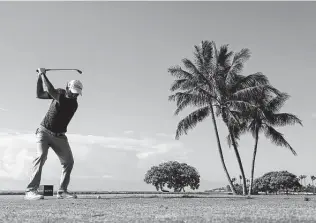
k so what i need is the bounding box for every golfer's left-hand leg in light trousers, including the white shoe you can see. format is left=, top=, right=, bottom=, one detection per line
left=25, top=132, right=49, bottom=200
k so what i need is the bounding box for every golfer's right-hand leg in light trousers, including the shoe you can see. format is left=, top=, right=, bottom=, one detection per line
left=52, top=136, right=74, bottom=197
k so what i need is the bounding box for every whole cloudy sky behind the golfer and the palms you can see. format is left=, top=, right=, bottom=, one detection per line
left=0, top=2, right=316, bottom=191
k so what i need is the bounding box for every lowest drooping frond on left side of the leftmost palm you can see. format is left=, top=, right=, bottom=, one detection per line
left=175, top=106, right=210, bottom=139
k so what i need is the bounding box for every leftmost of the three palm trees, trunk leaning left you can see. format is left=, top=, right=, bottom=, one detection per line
left=168, top=41, right=236, bottom=195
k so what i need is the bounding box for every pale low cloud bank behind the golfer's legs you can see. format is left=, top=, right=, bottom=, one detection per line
left=0, top=129, right=189, bottom=186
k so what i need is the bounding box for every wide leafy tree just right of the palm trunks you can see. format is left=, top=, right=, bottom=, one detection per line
left=253, top=171, right=301, bottom=194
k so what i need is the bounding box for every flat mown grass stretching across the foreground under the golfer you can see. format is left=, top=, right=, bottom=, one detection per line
left=0, top=194, right=316, bottom=223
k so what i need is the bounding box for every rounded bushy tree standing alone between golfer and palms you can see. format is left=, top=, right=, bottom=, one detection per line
left=144, top=161, right=200, bottom=192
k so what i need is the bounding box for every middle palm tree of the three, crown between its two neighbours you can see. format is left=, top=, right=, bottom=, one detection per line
left=207, top=45, right=277, bottom=195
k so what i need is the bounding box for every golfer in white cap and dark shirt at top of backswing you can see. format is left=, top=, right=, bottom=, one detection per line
left=25, top=68, right=83, bottom=200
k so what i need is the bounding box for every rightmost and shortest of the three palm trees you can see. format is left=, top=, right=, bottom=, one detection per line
left=243, top=88, right=302, bottom=195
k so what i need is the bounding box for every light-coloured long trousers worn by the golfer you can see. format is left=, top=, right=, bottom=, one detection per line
left=26, top=126, right=74, bottom=191
